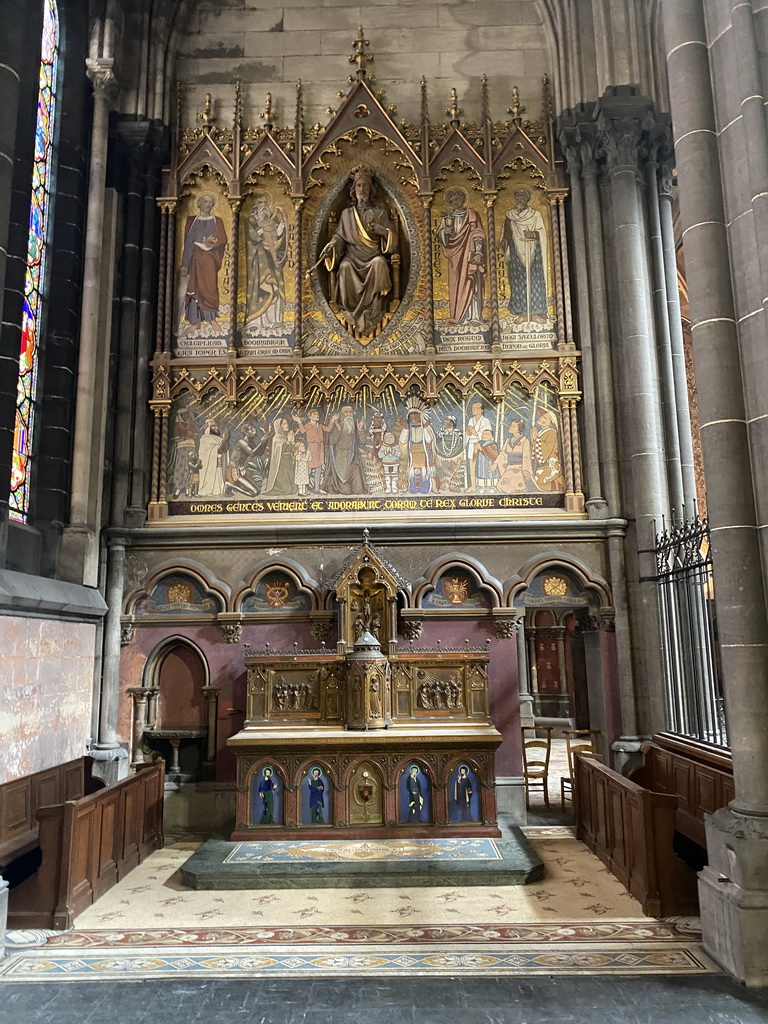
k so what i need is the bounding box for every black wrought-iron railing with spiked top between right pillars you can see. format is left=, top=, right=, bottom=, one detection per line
left=655, top=516, right=728, bottom=746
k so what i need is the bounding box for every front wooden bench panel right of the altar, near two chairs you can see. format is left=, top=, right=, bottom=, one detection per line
left=573, top=755, right=698, bottom=918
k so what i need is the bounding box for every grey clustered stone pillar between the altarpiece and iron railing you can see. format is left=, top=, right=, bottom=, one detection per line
left=559, top=92, right=695, bottom=762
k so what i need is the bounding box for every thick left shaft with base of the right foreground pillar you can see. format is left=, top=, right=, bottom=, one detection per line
left=662, top=0, right=768, bottom=985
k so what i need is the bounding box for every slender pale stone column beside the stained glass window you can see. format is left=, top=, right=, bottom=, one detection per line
left=60, top=57, right=117, bottom=587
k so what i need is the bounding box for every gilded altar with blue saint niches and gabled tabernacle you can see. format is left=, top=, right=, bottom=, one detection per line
left=227, top=539, right=502, bottom=840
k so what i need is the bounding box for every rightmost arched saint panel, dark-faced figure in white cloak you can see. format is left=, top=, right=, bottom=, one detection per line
left=496, top=182, right=557, bottom=352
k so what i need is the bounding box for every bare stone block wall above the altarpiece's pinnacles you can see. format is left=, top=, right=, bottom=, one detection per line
left=176, top=0, right=552, bottom=125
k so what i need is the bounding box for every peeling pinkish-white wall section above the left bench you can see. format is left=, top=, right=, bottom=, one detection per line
left=0, top=615, right=96, bottom=783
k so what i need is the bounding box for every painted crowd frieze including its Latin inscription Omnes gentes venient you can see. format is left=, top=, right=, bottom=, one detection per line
left=167, top=385, right=564, bottom=515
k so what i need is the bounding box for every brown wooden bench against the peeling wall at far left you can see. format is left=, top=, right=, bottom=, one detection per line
left=0, top=758, right=104, bottom=871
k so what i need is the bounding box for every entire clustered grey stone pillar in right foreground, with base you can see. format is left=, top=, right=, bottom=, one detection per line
left=662, top=0, right=768, bottom=985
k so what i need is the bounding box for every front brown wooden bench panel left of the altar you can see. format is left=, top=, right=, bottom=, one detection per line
left=8, top=761, right=165, bottom=929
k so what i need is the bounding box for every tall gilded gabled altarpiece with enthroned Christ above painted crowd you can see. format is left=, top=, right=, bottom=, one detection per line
left=148, top=28, right=584, bottom=524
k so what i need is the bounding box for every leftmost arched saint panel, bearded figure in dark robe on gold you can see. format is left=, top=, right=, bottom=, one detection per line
left=171, top=179, right=231, bottom=357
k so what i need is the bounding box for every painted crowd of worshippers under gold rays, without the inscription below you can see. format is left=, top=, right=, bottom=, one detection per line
left=168, top=399, right=564, bottom=500
